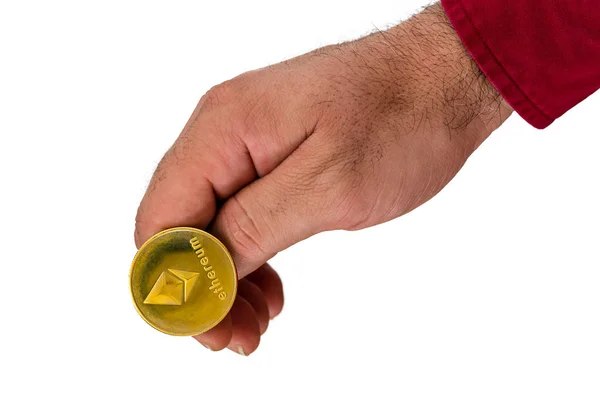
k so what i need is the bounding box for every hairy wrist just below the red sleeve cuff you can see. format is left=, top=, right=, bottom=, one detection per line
left=375, top=3, right=512, bottom=151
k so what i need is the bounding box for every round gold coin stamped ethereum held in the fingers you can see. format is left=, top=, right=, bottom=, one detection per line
left=129, top=228, right=237, bottom=336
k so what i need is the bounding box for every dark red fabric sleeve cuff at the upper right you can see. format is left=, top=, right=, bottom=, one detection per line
left=442, top=0, right=600, bottom=129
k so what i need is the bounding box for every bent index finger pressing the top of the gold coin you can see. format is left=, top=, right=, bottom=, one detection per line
left=135, top=84, right=256, bottom=246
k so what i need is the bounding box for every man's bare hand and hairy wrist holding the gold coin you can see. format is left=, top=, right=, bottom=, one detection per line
left=135, top=4, right=512, bottom=355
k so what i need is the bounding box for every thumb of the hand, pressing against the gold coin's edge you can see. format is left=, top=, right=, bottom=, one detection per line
left=210, top=136, right=344, bottom=278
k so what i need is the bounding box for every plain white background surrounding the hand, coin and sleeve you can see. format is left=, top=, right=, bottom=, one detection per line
left=0, top=0, right=600, bottom=400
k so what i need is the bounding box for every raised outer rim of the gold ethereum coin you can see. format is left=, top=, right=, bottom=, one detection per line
left=129, top=226, right=238, bottom=336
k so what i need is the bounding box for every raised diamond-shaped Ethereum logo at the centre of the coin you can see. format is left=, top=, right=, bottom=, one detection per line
left=144, top=269, right=200, bottom=306
